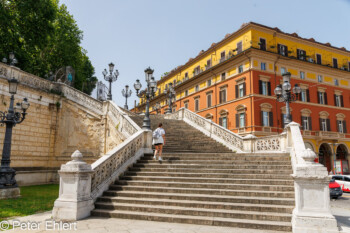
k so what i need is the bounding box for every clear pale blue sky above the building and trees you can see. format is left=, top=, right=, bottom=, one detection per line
left=60, top=0, right=350, bottom=108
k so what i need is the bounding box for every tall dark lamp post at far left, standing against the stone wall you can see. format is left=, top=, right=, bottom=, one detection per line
left=0, top=78, right=29, bottom=189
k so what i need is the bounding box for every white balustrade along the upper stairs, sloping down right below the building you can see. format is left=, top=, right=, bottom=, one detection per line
left=166, top=108, right=244, bottom=152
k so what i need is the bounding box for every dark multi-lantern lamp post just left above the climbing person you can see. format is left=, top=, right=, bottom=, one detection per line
left=134, top=67, right=157, bottom=130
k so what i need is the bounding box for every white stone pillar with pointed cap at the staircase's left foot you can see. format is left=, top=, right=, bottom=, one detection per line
left=52, top=150, right=94, bottom=221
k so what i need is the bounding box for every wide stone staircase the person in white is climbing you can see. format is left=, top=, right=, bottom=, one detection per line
left=92, top=116, right=295, bottom=232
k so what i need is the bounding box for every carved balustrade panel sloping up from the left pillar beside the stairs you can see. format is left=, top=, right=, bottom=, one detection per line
left=91, top=134, right=143, bottom=192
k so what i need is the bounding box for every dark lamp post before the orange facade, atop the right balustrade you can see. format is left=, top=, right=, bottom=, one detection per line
left=274, top=72, right=301, bottom=125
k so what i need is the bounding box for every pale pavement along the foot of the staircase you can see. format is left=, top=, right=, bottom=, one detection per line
left=6, top=211, right=281, bottom=233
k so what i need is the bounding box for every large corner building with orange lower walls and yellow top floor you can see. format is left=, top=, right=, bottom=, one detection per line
left=137, top=23, right=350, bottom=174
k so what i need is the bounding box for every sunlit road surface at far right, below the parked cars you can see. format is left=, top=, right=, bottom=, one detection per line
left=331, top=193, right=350, bottom=233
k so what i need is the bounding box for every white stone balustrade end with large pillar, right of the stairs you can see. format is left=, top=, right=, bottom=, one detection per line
left=286, top=122, right=339, bottom=233
